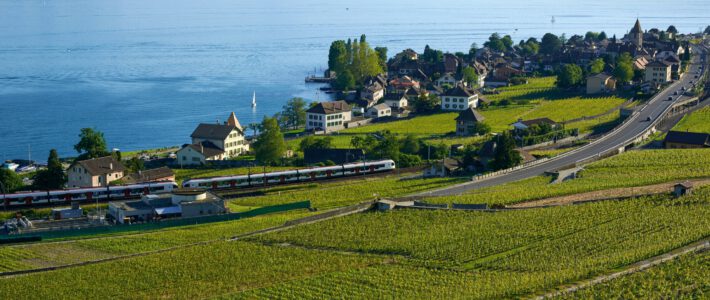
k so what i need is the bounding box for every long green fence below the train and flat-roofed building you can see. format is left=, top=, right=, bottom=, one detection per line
left=0, top=201, right=311, bottom=240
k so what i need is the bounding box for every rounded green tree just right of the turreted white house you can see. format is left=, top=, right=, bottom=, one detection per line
left=253, top=117, right=286, bottom=164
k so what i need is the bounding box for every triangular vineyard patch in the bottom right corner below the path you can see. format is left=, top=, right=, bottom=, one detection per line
left=559, top=251, right=710, bottom=299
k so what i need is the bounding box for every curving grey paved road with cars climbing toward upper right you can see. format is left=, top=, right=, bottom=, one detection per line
left=426, top=42, right=708, bottom=196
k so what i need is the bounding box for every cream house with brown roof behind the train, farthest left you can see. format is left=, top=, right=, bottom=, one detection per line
left=67, top=156, right=126, bottom=188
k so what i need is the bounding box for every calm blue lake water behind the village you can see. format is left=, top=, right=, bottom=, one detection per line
left=0, top=0, right=710, bottom=159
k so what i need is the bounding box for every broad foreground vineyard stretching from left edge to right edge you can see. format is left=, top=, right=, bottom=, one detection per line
left=0, top=176, right=710, bottom=299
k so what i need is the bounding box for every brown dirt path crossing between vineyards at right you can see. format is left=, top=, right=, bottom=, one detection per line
left=507, top=178, right=710, bottom=208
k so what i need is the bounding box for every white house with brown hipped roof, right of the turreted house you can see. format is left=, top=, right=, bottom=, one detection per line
left=306, top=100, right=352, bottom=133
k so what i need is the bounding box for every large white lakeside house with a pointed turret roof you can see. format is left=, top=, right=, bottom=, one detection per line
left=176, top=112, right=249, bottom=165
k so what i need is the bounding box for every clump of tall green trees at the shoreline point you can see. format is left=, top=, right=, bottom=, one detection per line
left=328, top=34, right=387, bottom=90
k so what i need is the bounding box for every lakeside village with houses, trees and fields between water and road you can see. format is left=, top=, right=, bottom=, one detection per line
left=3, top=20, right=710, bottom=230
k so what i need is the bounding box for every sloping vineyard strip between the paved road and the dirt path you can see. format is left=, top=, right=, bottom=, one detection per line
left=427, top=149, right=710, bottom=205
